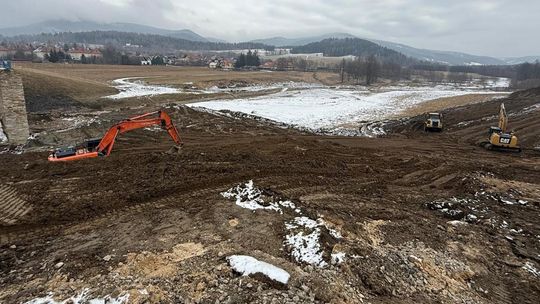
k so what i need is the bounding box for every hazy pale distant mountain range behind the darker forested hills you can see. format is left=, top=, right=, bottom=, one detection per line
left=0, top=20, right=540, bottom=65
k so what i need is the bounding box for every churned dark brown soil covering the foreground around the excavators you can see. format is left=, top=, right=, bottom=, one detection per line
left=0, top=67, right=540, bottom=303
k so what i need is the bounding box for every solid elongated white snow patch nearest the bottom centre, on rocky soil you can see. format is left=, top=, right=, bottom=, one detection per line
left=227, top=255, right=290, bottom=284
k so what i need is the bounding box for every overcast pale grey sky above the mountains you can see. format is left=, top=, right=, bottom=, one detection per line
left=0, top=0, right=540, bottom=56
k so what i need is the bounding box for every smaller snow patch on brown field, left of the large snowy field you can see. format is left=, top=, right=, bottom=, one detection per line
left=105, top=77, right=182, bottom=99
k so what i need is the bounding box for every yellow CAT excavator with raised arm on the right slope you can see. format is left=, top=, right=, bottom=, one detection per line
left=480, top=103, right=521, bottom=152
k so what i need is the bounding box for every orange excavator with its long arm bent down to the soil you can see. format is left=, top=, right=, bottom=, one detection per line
left=49, top=111, right=182, bottom=162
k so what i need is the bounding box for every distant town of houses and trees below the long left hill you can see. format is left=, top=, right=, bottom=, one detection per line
left=0, top=42, right=332, bottom=70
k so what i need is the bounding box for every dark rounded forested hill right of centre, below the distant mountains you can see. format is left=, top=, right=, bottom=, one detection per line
left=292, top=38, right=418, bottom=65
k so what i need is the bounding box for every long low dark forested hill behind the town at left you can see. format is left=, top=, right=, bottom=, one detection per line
left=4, top=31, right=274, bottom=51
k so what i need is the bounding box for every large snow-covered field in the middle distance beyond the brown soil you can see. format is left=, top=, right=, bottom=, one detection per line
left=188, top=80, right=506, bottom=130
